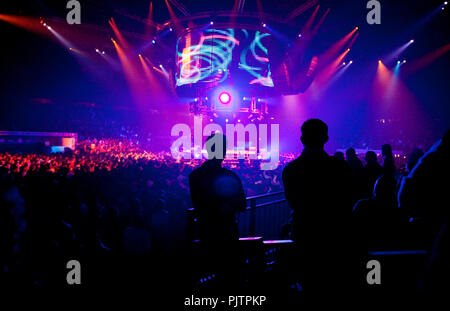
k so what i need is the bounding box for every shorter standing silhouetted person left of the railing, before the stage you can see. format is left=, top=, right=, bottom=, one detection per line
left=189, top=133, right=246, bottom=252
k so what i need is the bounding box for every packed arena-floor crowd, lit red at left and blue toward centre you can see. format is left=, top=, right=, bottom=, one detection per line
left=0, top=138, right=292, bottom=288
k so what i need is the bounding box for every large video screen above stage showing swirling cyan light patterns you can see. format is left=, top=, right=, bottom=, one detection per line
left=176, top=28, right=274, bottom=87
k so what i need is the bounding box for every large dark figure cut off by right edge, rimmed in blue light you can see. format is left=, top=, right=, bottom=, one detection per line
left=398, top=130, right=450, bottom=294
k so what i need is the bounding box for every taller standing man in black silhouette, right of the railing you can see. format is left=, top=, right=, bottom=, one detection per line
left=283, top=119, right=353, bottom=291
